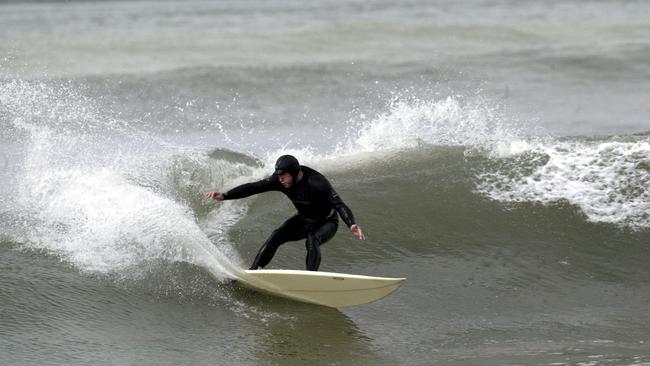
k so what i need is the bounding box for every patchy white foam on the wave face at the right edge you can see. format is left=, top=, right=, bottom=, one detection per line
left=478, top=138, right=650, bottom=228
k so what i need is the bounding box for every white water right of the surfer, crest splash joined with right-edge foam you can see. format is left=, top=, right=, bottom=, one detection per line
left=334, top=97, right=650, bottom=229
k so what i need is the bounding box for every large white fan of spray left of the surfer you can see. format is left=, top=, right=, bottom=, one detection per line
left=0, top=80, right=241, bottom=278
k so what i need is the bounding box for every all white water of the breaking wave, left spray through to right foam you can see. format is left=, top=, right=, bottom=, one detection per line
left=0, top=76, right=650, bottom=294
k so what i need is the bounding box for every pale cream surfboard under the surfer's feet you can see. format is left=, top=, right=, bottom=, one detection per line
left=233, top=269, right=406, bottom=308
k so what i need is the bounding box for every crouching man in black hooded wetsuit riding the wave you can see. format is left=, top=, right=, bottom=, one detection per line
left=206, top=155, right=366, bottom=271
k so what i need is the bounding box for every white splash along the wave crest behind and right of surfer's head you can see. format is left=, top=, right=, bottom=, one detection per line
left=253, top=95, right=525, bottom=174
